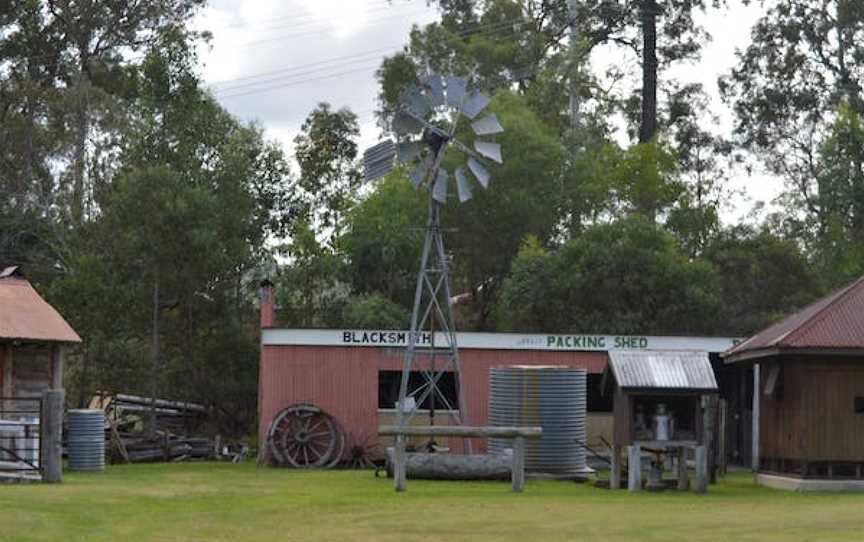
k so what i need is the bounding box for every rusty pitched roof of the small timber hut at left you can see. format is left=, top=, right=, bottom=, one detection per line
left=0, top=275, right=81, bottom=343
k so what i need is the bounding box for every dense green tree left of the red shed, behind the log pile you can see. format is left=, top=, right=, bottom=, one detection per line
left=49, top=40, right=296, bottom=429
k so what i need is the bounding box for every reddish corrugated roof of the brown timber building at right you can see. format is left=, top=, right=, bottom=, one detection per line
left=723, top=277, right=864, bottom=361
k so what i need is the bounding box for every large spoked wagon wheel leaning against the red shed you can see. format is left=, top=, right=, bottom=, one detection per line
left=267, top=405, right=344, bottom=469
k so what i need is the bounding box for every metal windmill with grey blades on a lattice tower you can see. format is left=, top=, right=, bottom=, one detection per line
left=363, top=73, right=504, bottom=444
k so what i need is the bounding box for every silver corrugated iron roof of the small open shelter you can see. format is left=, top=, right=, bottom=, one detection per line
left=609, top=350, right=717, bottom=390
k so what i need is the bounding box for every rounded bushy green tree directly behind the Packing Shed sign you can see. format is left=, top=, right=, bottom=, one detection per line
left=499, top=216, right=721, bottom=335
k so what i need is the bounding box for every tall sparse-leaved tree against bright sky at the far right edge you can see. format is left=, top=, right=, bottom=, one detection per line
left=721, top=0, right=864, bottom=282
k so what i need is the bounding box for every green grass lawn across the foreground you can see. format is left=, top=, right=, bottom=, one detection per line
left=0, top=463, right=864, bottom=542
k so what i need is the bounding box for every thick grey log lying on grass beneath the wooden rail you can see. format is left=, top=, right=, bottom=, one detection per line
left=387, top=447, right=513, bottom=480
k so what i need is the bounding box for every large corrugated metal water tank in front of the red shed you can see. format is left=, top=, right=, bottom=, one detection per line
left=489, top=365, right=590, bottom=476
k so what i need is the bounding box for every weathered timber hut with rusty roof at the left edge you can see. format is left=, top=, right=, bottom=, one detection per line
left=0, top=267, right=81, bottom=411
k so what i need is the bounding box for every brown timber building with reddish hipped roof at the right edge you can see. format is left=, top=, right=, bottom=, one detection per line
left=723, top=277, right=864, bottom=491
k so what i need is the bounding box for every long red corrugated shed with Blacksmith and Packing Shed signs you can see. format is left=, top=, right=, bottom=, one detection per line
left=258, top=287, right=734, bottom=462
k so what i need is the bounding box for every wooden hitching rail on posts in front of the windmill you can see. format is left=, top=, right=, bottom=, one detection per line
left=378, top=425, right=543, bottom=492
